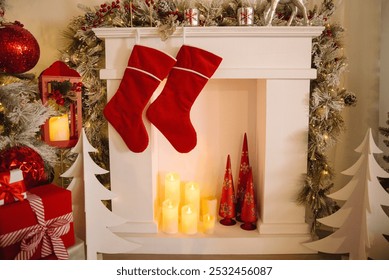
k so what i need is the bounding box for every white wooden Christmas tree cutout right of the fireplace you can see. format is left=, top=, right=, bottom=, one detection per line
left=304, top=129, right=389, bottom=260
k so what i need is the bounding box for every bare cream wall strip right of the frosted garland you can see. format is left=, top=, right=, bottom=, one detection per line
left=334, top=0, right=386, bottom=187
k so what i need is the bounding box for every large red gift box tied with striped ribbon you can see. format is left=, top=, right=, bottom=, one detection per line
left=0, top=184, right=75, bottom=259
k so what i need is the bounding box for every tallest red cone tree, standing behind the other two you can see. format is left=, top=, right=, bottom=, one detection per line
left=236, top=133, right=250, bottom=222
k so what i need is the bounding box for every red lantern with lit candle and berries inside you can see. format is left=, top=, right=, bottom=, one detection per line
left=39, top=61, right=82, bottom=148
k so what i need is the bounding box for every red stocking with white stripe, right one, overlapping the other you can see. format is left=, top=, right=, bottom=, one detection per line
left=146, top=45, right=222, bottom=153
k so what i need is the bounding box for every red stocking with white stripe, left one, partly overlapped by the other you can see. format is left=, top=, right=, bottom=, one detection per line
left=103, top=45, right=176, bottom=153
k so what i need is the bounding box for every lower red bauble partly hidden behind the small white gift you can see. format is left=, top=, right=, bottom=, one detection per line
left=0, top=146, right=48, bottom=189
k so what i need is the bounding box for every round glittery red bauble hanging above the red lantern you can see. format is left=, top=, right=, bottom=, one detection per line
left=0, top=24, right=40, bottom=74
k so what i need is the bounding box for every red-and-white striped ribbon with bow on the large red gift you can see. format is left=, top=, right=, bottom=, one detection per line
left=0, top=193, right=73, bottom=260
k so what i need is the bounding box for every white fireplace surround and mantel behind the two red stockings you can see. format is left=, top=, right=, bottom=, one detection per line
left=94, top=26, right=323, bottom=254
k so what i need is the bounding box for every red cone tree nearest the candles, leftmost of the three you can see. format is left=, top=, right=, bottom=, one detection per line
left=219, top=155, right=236, bottom=226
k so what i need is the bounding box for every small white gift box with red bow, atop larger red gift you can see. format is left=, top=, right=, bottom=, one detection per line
left=0, top=169, right=27, bottom=206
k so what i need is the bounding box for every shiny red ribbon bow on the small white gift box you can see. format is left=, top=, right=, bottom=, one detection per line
left=0, top=171, right=24, bottom=204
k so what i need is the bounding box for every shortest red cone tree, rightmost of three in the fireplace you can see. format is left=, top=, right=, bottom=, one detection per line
left=240, top=168, right=258, bottom=230
